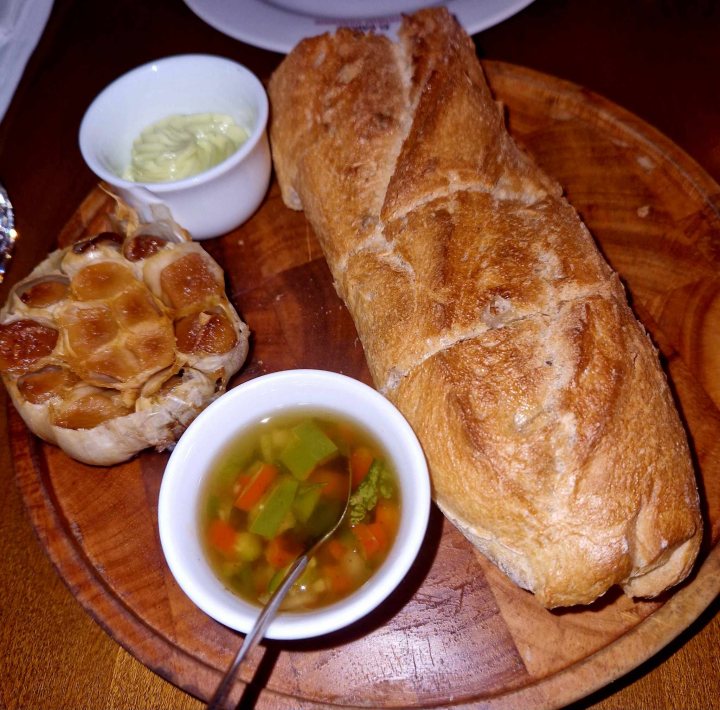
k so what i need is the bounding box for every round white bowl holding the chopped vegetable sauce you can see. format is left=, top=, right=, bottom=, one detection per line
left=158, top=370, right=430, bottom=639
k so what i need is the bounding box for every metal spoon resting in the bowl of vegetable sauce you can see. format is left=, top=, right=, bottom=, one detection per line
left=207, top=467, right=352, bottom=710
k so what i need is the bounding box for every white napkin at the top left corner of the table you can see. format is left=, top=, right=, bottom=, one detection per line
left=0, top=0, right=53, bottom=121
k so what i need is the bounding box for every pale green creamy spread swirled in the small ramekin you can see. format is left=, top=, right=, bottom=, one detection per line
left=122, top=113, right=248, bottom=183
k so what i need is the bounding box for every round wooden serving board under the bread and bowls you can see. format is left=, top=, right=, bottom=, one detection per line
left=10, top=62, right=720, bottom=708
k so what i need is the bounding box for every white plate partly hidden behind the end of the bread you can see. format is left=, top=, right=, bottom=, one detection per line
left=185, top=0, right=533, bottom=53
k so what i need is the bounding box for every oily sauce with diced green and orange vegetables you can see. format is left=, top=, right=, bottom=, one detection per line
left=199, top=410, right=400, bottom=610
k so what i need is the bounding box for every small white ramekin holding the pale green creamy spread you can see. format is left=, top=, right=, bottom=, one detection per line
left=79, top=54, right=271, bottom=239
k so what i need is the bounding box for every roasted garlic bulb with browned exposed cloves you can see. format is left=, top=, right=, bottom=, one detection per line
left=0, top=214, right=248, bottom=465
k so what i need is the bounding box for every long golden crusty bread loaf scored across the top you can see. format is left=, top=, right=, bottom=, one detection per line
left=270, top=9, right=702, bottom=607
